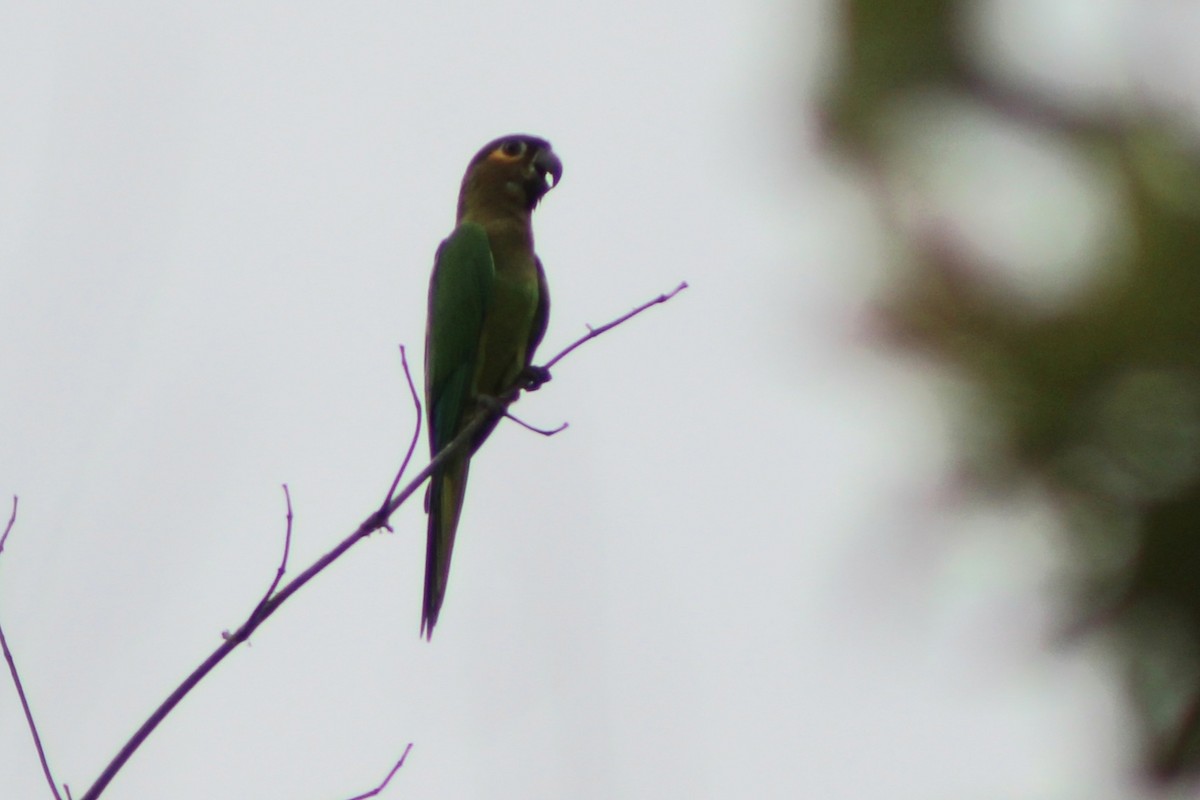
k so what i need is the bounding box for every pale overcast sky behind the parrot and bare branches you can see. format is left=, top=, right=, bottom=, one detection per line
left=0, top=0, right=1195, bottom=800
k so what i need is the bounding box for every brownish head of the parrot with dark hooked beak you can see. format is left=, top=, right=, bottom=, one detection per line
left=458, top=133, right=563, bottom=219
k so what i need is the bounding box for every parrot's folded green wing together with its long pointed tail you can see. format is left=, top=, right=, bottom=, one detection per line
left=421, top=222, right=496, bottom=636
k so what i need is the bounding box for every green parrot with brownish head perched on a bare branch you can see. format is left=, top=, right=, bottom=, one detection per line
left=421, top=134, right=563, bottom=639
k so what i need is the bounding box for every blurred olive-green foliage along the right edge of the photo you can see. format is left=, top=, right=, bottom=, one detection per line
left=823, top=0, right=1200, bottom=781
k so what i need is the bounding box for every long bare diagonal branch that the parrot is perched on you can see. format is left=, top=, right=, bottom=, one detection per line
left=82, top=283, right=688, bottom=800
